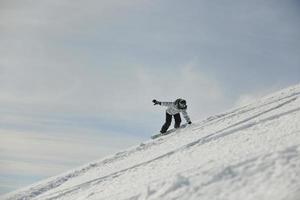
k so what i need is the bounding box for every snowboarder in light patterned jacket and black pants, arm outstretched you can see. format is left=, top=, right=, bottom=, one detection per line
left=152, top=99, right=192, bottom=134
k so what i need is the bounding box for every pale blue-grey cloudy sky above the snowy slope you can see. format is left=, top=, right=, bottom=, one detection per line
left=0, top=0, right=300, bottom=194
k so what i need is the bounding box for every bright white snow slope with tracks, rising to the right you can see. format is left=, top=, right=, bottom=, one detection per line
left=2, top=85, right=300, bottom=200
